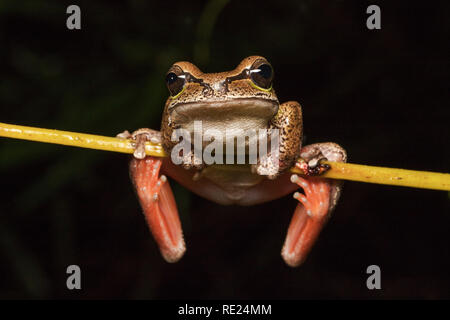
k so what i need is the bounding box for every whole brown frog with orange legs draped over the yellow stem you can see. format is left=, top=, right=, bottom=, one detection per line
left=118, top=56, right=347, bottom=267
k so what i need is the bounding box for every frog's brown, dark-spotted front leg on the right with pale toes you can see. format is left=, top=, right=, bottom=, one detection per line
left=252, top=101, right=303, bottom=180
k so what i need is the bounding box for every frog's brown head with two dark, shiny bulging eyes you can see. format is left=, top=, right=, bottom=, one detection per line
left=165, top=56, right=279, bottom=134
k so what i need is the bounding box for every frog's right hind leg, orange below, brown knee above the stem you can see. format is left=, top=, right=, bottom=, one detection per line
left=281, top=143, right=347, bottom=267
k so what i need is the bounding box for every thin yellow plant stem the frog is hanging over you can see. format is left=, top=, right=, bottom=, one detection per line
left=0, top=123, right=450, bottom=191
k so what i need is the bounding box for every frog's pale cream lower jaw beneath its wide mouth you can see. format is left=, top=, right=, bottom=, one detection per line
left=169, top=98, right=279, bottom=132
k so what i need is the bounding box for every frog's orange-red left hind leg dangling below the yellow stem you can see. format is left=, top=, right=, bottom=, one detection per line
left=130, top=157, right=186, bottom=262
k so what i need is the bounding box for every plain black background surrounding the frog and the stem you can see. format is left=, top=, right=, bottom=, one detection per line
left=0, top=0, right=450, bottom=299
